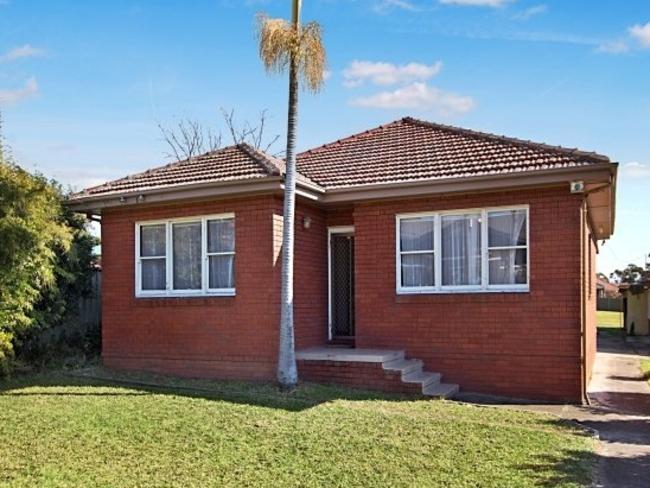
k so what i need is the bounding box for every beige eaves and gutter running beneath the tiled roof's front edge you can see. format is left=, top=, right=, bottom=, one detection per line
left=67, top=163, right=618, bottom=239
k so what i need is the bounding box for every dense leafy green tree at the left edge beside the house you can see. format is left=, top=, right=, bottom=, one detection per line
left=0, top=113, right=95, bottom=375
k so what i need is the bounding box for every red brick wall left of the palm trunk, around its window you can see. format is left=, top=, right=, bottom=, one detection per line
left=102, top=196, right=279, bottom=379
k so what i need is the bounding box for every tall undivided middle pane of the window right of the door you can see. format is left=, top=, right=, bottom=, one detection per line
left=441, top=214, right=481, bottom=286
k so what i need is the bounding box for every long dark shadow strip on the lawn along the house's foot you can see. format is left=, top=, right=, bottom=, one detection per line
left=0, top=367, right=421, bottom=411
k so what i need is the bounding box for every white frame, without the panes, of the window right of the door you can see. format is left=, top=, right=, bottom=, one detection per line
left=395, top=205, right=530, bottom=295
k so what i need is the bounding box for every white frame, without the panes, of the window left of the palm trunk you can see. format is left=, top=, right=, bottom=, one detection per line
left=135, top=213, right=237, bottom=298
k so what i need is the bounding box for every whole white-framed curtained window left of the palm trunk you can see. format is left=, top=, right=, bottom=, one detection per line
left=136, top=214, right=235, bottom=296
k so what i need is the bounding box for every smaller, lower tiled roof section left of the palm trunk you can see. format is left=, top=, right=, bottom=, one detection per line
left=70, top=144, right=284, bottom=200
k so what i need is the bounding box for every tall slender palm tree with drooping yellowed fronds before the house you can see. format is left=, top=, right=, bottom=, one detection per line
left=258, top=0, right=325, bottom=389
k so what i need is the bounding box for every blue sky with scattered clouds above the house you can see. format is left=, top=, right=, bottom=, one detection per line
left=0, top=0, right=650, bottom=272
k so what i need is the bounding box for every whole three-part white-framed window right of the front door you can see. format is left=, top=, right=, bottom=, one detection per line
left=397, top=207, right=528, bottom=293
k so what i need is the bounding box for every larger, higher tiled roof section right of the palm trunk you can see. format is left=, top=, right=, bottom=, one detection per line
left=298, top=117, right=609, bottom=188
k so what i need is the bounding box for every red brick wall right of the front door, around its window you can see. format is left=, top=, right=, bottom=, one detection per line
left=354, top=188, right=581, bottom=401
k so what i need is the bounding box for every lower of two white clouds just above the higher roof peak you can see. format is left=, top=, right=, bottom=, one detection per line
left=350, top=82, right=476, bottom=116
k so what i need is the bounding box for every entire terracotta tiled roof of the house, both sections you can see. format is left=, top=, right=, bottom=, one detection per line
left=69, top=117, right=609, bottom=201
